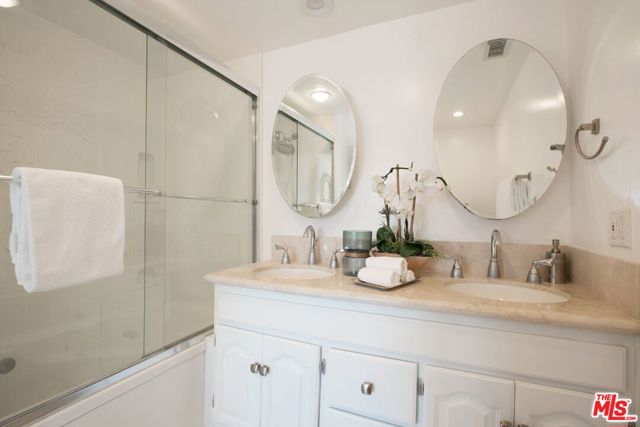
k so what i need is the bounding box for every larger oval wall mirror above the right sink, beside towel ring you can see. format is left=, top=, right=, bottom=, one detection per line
left=434, top=39, right=567, bottom=219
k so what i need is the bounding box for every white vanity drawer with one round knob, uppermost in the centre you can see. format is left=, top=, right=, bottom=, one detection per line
left=325, top=349, right=418, bottom=426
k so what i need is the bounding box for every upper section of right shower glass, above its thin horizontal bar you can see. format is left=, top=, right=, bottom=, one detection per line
left=166, top=50, right=255, bottom=200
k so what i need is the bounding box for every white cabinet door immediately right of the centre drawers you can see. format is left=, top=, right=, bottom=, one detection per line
left=424, top=367, right=514, bottom=427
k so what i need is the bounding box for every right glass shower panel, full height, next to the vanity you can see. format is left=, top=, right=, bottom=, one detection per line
left=145, top=44, right=255, bottom=353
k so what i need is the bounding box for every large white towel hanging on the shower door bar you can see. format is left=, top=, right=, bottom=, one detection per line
left=9, top=168, right=125, bottom=292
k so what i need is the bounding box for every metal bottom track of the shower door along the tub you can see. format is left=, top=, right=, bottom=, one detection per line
left=0, top=325, right=213, bottom=427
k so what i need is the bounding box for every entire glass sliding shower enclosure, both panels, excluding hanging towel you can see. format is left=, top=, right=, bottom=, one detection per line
left=0, top=0, right=255, bottom=424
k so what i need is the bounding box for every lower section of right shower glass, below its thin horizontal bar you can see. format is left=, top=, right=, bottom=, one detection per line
left=164, top=198, right=252, bottom=344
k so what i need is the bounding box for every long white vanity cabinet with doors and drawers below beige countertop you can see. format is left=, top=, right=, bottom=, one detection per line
left=207, top=284, right=640, bottom=427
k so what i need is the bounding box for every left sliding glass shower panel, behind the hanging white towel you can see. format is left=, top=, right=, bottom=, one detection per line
left=0, top=0, right=146, bottom=420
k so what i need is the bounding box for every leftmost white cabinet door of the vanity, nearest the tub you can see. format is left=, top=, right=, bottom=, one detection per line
left=213, top=326, right=262, bottom=427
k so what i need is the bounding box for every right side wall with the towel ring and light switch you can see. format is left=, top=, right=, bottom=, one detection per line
left=569, top=0, right=640, bottom=261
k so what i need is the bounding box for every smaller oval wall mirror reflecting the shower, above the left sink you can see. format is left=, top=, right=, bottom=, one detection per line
left=271, top=76, right=356, bottom=218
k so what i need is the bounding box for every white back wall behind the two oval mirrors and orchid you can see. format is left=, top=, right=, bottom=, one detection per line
left=227, top=0, right=569, bottom=258
